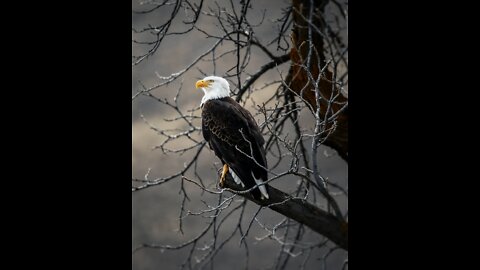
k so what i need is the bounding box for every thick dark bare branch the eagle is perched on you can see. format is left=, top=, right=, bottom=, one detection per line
left=224, top=175, right=348, bottom=250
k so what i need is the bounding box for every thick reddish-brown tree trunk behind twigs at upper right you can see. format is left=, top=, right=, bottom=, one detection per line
left=286, top=0, right=348, bottom=162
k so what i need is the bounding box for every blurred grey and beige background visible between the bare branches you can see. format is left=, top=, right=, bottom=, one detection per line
left=132, top=0, right=348, bottom=270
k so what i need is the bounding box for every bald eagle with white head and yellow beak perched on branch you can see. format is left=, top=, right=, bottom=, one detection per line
left=195, top=76, right=268, bottom=200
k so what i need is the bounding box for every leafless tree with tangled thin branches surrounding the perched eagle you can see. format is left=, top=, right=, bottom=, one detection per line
left=132, top=0, right=348, bottom=269
